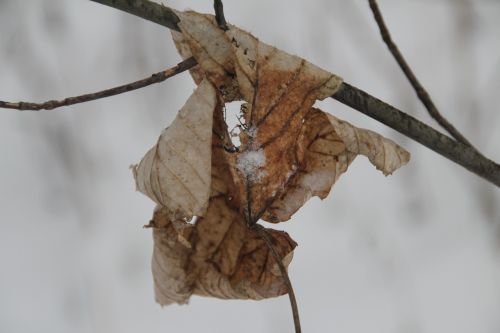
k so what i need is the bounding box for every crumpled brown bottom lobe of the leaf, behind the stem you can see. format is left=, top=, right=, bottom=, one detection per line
left=152, top=107, right=296, bottom=305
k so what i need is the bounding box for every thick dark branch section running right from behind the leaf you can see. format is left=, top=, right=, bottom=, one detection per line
left=332, top=83, right=500, bottom=186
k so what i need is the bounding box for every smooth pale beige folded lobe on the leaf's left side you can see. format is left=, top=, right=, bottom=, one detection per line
left=134, top=80, right=221, bottom=219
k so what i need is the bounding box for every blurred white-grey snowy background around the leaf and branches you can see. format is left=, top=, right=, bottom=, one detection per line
left=0, top=0, right=500, bottom=333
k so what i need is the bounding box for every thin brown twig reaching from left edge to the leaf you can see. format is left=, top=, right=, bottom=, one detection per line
left=0, top=58, right=196, bottom=111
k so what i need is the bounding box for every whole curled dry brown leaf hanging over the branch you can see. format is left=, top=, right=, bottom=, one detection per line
left=134, top=12, right=409, bottom=304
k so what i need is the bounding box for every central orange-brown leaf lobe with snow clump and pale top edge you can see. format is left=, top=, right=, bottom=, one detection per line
left=228, top=29, right=341, bottom=222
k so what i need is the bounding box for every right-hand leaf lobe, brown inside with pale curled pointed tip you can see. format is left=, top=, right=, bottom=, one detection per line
left=262, top=109, right=410, bottom=223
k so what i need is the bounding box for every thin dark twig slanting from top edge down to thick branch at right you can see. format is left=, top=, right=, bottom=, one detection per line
left=368, top=0, right=475, bottom=149
